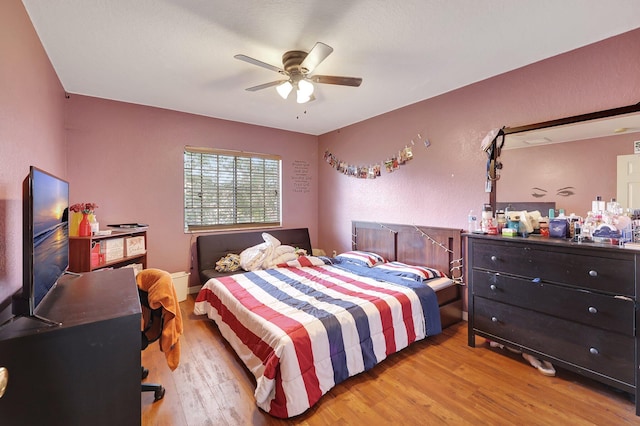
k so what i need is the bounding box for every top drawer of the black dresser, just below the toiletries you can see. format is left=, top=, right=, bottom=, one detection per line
left=471, top=240, right=635, bottom=297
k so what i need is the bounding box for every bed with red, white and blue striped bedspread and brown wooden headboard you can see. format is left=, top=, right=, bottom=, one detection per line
left=194, top=221, right=462, bottom=418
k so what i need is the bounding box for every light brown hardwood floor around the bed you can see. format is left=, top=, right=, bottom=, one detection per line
left=142, top=295, right=640, bottom=426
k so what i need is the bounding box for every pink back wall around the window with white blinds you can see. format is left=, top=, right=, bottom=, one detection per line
left=66, top=95, right=318, bottom=285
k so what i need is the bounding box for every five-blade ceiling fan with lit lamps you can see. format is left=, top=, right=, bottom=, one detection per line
left=234, top=42, right=362, bottom=104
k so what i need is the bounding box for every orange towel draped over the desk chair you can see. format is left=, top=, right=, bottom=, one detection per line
left=136, top=269, right=182, bottom=371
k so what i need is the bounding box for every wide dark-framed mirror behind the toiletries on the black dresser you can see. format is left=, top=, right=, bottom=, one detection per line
left=490, top=103, right=640, bottom=216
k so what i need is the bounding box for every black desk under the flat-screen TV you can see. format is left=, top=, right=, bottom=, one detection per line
left=0, top=268, right=141, bottom=425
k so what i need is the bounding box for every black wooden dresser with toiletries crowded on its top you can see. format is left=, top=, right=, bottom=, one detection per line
left=467, top=234, right=640, bottom=415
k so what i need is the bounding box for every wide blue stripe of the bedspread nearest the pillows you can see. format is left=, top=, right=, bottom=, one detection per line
left=333, top=262, right=442, bottom=336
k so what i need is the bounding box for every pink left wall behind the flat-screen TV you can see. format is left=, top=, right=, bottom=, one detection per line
left=0, top=0, right=67, bottom=310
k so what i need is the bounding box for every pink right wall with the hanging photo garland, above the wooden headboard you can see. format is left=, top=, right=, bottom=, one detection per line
left=318, top=29, right=640, bottom=251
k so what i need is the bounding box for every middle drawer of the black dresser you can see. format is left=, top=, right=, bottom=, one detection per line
left=472, top=269, right=635, bottom=336
